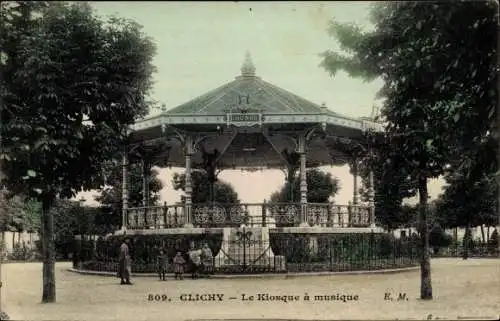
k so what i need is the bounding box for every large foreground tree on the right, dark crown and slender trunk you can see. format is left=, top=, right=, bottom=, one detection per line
left=322, top=1, right=498, bottom=299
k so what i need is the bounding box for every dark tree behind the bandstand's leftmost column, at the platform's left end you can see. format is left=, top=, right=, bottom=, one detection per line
left=95, top=164, right=163, bottom=233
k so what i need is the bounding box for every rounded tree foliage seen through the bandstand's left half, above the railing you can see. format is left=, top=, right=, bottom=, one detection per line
left=172, top=170, right=239, bottom=204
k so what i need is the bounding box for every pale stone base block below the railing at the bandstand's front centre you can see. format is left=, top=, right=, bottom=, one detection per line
left=215, top=226, right=286, bottom=272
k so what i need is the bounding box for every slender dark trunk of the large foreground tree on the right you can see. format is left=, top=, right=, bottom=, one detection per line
left=418, top=175, right=432, bottom=300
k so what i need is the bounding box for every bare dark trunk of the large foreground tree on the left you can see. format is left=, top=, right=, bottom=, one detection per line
left=41, top=194, right=56, bottom=303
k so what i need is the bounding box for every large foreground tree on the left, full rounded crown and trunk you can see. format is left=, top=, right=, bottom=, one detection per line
left=0, top=2, right=155, bottom=302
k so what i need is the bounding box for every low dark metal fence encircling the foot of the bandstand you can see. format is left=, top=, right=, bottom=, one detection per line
left=74, top=233, right=418, bottom=274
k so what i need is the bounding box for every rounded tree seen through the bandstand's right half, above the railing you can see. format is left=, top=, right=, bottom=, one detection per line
left=270, top=168, right=340, bottom=203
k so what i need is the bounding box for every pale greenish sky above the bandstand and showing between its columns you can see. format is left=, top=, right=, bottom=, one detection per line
left=77, top=1, right=443, bottom=205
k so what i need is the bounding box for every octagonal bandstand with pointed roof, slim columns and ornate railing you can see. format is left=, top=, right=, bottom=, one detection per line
left=74, top=53, right=418, bottom=272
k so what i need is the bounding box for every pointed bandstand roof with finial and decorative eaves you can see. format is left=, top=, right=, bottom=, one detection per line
left=130, top=53, right=383, bottom=168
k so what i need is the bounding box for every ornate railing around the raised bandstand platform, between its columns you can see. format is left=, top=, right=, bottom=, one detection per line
left=126, top=203, right=372, bottom=229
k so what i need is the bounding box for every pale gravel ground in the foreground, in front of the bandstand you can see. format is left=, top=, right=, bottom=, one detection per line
left=2, top=259, right=500, bottom=321
